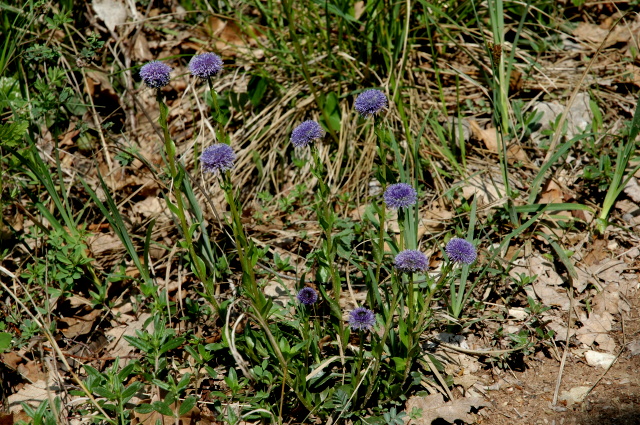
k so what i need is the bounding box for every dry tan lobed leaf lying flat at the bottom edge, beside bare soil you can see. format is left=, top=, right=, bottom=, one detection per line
left=405, top=393, right=489, bottom=425
